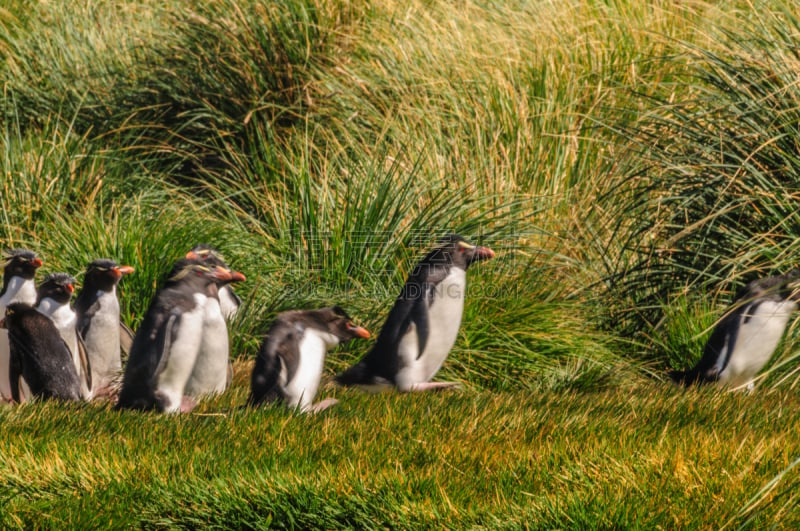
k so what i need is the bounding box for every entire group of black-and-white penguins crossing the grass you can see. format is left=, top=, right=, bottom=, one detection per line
left=0, top=234, right=800, bottom=413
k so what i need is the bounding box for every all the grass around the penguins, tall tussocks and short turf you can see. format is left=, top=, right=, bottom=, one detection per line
left=0, top=0, right=800, bottom=528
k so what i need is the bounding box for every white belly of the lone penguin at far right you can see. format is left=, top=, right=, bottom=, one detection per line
left=719, top=301, right=797, bottom=387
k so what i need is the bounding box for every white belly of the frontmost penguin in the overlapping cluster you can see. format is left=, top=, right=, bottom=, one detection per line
left=156, top=294, right=206, bottom=413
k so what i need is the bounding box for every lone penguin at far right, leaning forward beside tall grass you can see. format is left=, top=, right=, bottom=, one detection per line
left=670, top=270, right=800, bottom=389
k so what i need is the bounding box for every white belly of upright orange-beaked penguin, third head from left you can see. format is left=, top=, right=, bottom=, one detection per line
left=83, top=290, right=122, bottom=391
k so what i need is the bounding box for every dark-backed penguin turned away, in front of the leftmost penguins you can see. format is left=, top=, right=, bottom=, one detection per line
left=2, top=302, right=80, bottom=402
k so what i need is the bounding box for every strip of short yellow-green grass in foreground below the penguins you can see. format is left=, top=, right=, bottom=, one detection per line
left=0, top=374, right=800, bottom=529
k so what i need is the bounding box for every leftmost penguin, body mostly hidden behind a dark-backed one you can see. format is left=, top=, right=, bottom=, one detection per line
left=0, top=249, right=42, bottom=401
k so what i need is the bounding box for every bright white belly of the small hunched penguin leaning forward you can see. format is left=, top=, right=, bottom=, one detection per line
left=283, top=328, right=332, bottom=411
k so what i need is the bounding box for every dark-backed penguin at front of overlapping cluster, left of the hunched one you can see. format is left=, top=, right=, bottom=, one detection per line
left=117, top=260, right=231, bottom=413
